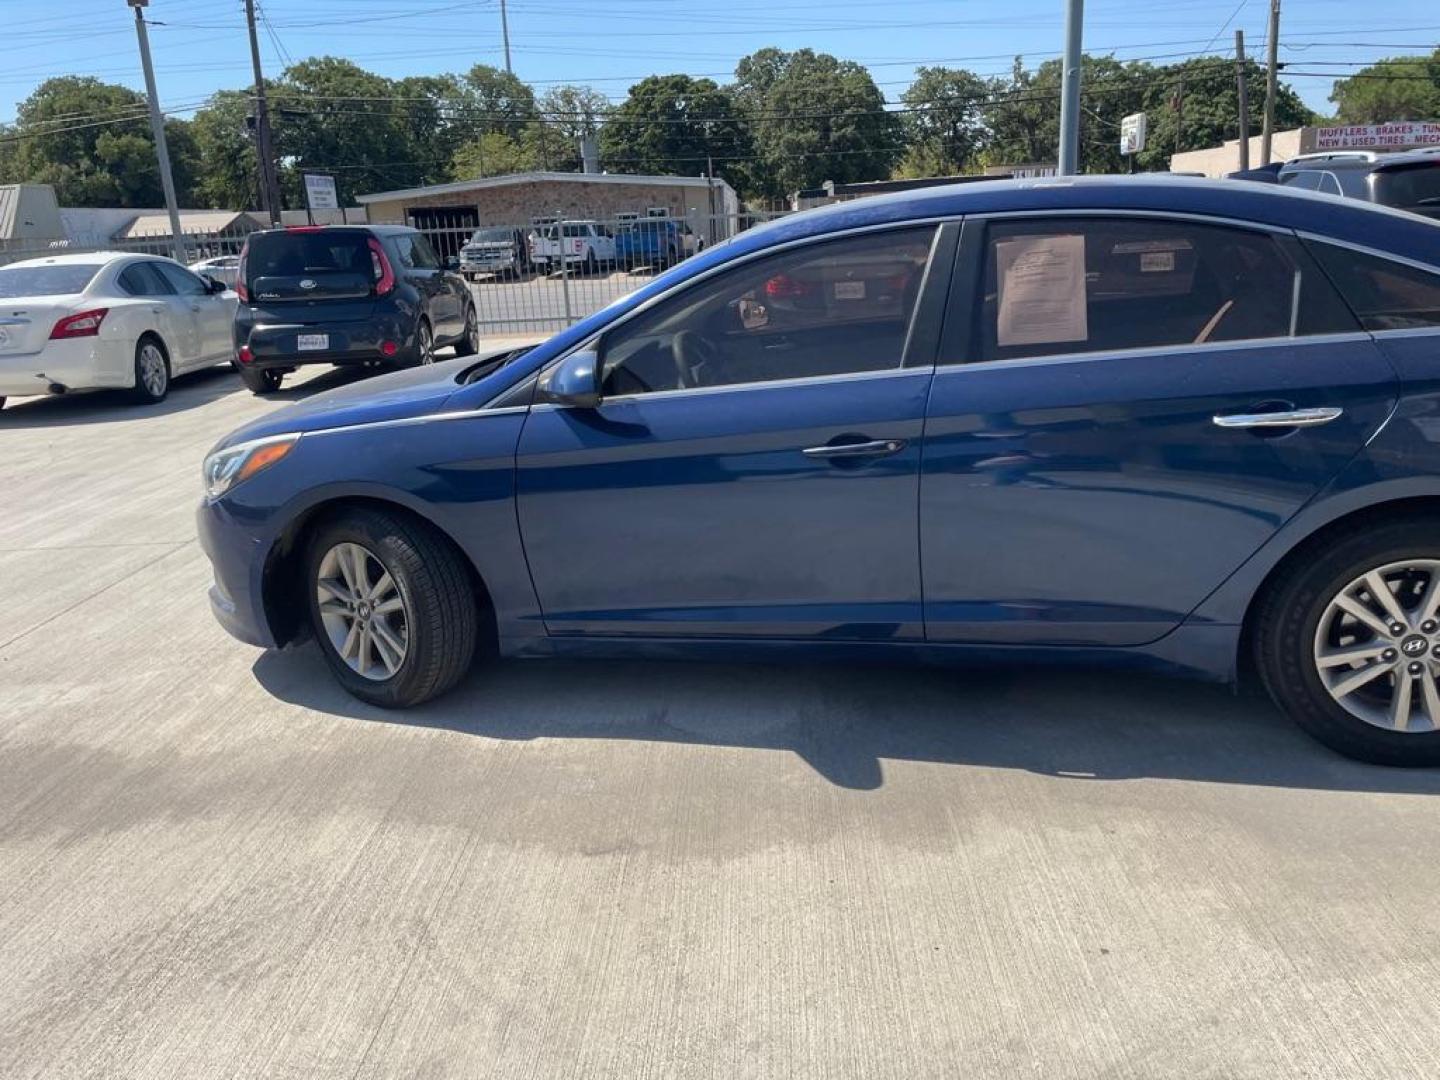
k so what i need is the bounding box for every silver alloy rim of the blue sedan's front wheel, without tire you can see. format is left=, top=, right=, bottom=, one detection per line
left=315, top=543, right=410, bottom=683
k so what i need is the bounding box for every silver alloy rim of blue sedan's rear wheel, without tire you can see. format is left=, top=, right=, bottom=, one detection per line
left=1315, top=559, right=1440, bottom=733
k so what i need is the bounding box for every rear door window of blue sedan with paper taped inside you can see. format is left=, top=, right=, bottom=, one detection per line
left=972, top=217, right=1356, bottom=360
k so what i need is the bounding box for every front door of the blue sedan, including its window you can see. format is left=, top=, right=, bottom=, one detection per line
left=517, top=226, right=943, bottom=639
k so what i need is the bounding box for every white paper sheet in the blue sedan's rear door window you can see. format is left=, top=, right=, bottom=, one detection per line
left=995, top=236, right=1090, bottom=348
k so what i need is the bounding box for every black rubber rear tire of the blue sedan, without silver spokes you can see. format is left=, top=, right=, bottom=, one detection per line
left=1254, top=517, right=1440, bottom=766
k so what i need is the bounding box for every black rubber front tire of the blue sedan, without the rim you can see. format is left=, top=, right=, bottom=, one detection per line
left=302, top=510, right=480, bottom=708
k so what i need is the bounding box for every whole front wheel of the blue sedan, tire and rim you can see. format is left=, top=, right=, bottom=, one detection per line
left=305, top=510, right=478, bottom=708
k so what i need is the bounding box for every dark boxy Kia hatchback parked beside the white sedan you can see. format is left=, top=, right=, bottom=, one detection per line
left=235, top=225, right=480, bottom=393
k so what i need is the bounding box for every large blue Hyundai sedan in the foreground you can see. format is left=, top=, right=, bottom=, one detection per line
left=199, top=177, right=1440, bottom=765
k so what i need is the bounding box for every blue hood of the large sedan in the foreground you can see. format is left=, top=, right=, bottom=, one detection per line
left=216, top=340, right=533, bottom=449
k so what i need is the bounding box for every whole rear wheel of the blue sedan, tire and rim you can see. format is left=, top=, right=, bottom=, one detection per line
left=1256, top=518, right=1440, bottom=765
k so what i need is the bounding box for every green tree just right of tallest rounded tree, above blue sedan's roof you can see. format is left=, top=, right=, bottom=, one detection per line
left=899, top=68, right=989, bottom=177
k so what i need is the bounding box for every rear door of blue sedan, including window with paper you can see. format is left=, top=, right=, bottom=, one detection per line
left=920, top=217, right=1397, bottom=645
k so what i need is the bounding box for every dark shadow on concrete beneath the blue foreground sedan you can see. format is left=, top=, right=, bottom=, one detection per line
left=253, top=644, right=1440, bottom=793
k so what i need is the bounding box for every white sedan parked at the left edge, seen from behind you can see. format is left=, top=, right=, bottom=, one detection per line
left=0, top=252, right=236, bottom=406
